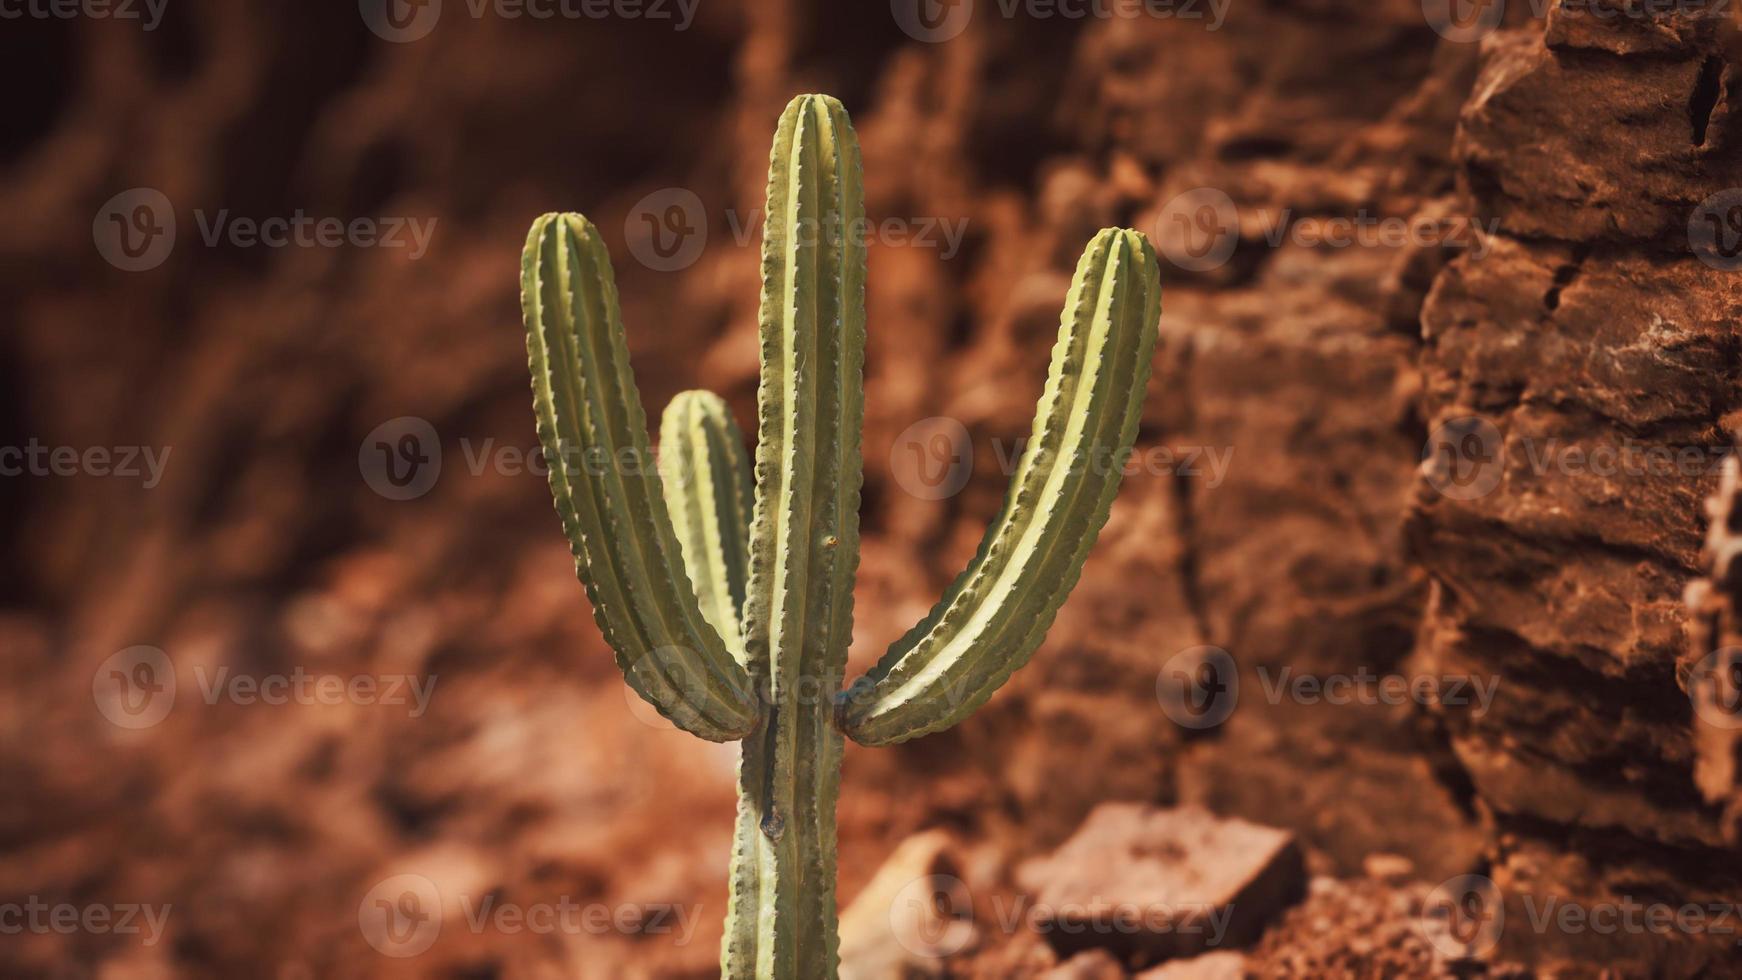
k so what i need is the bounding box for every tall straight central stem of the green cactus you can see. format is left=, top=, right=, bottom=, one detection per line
left=721, top=96, right=866, bottom=980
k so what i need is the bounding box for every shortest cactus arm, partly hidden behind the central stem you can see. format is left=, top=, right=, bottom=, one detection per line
left=658, top=392, right=753, bottom=667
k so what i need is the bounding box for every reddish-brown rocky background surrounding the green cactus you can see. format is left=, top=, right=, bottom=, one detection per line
left=0, top=0, right=1742, bottom=980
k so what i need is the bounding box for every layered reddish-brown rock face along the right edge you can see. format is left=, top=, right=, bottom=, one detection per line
left=1409, top=5, right=1742, bottom=971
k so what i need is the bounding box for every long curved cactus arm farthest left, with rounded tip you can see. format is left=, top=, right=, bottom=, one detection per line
left=521, top=214, right=758, bottom=742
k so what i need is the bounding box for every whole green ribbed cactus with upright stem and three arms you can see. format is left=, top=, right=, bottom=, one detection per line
left=521, top=96, right=1160, bottom=980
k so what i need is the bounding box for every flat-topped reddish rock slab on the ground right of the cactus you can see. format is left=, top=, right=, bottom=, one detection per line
left=1019, top=802, right=1307, bottom=968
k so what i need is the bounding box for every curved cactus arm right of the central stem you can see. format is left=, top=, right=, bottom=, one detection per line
left=841, top=228, right=1160, bottom=745
